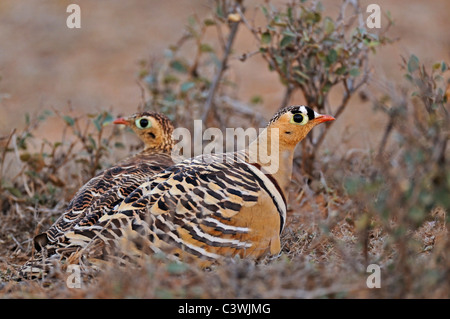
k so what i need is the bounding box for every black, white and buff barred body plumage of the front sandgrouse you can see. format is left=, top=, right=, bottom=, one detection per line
left=66, top=152, right=286, bottom=261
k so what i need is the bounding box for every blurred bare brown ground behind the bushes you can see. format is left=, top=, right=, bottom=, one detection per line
left=0, top=0, right=450, bottom=151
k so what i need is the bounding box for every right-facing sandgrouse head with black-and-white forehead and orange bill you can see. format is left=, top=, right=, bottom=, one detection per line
left=268, top=105, right=335, bottom=149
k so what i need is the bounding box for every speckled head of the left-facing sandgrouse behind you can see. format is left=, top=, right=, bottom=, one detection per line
left=113, top=112, right=174, bottom=152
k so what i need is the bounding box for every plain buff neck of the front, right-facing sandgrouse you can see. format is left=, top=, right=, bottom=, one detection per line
left=248, top=127, right=295, bottom=194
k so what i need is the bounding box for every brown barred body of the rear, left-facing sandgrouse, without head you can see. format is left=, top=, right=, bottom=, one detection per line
left=18, top=152, right=173, bottom=278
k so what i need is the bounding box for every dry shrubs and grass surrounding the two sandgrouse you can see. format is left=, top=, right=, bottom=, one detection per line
left=0, top=1, right=450, bottom=298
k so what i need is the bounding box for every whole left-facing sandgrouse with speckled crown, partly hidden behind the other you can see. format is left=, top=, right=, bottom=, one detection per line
left=20, top=112, right=174, bottom=277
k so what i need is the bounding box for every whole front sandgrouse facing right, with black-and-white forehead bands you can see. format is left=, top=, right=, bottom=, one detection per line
left=75, top=106, right=334, bottom=266
